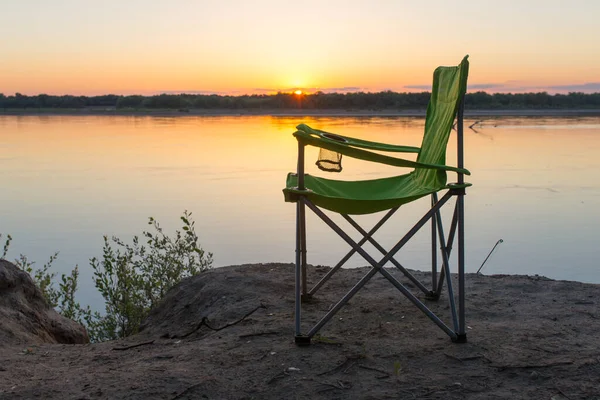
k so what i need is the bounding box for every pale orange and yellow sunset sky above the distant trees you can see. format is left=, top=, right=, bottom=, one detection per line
left=0, top=0, right=600, bottom=95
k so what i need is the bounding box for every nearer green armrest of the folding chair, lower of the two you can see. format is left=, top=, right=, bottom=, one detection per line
left=294, top=130, right=471, bottom=175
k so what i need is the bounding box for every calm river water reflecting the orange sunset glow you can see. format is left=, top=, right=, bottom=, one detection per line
left=0, top=116, right=600, bottom=305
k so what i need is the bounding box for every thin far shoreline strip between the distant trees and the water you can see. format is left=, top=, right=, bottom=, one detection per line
left=0, top=108, right=600, bottom=118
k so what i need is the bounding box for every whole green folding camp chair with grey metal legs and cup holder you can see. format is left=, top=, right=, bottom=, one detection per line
left=283, top=56, right=471, bottom=345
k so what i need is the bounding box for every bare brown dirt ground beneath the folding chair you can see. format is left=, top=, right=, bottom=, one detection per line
left=0, top=264, right=600, bottom=400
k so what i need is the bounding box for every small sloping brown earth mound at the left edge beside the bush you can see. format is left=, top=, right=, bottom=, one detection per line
left=0, top=260, right=89, bottom=347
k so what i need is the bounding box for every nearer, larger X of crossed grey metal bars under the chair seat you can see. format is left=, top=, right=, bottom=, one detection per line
left=296, top=192, right=458, bottom=340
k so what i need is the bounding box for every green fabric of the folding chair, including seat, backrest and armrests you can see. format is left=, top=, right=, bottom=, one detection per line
left=283, top=56, right=470, bottom=214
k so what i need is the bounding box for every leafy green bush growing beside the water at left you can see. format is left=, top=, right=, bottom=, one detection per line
left=0, top=211, right=213, bottom=342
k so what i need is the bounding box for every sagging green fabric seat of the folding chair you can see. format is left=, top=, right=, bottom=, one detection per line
left=283, top=172, right=447, bottom=215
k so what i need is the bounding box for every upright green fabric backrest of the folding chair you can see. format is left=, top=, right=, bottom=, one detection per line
left=413, top=56, right=469, bottom=187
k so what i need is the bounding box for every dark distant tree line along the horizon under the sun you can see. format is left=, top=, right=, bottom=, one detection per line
left=0, top=91, right=600, bottom=111
